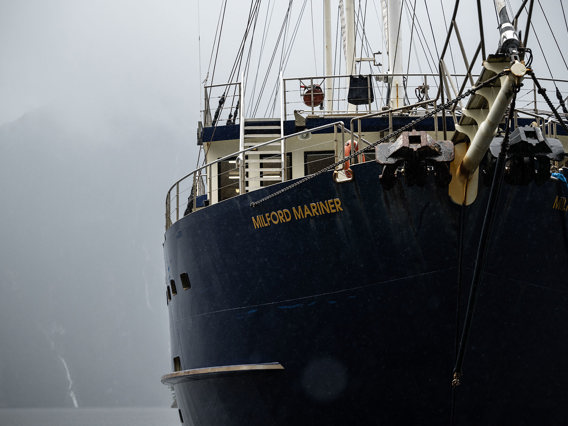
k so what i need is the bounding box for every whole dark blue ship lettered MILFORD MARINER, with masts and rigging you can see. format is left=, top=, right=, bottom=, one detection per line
left=162, top=0, right=568, bottom=425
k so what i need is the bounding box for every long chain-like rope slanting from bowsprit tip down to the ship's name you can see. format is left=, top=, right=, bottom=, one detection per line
left=250, top=70, right=508, bottom=207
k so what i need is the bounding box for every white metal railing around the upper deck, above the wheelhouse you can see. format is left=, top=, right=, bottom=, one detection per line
left=203, top=73, right=568, bottom=127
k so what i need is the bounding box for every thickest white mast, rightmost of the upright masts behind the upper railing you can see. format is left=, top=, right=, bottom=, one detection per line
left=382, top=0, right=404, bottom=109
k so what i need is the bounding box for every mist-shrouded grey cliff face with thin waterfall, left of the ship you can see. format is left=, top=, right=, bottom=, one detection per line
left=0, top=101, right=194, bottom=407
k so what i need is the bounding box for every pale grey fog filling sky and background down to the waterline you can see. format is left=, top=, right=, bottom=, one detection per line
left=0, top=0, right=562, bottom=407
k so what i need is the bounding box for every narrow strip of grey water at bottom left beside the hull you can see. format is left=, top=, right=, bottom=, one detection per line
left=0, top=408, right=180, bottom=426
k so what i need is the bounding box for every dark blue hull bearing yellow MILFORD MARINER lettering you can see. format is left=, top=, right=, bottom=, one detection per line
left=164, top=163, right=568, bottom=425
